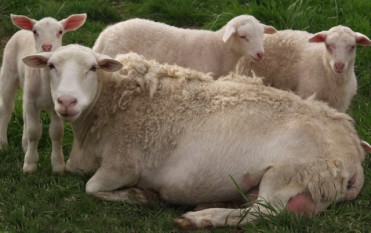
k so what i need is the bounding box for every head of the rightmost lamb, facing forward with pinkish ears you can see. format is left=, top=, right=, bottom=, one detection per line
left=309, top=25, right=371, bottom=74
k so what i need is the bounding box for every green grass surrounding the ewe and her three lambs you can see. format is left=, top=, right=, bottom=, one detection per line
left=0, top=0, right=371, bottom=232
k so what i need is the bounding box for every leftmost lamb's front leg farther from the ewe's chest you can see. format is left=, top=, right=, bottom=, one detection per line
left=23, top=101, right=42, bottom=173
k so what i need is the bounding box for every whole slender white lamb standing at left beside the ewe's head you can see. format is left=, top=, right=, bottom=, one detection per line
left=0, top=14, right=86, bottom=173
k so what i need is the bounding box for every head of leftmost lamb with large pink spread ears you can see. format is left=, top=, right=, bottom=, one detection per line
left=11, top=14, right=86, bottom=52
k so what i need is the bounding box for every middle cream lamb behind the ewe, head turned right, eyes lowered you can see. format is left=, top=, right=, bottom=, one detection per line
left=93, top=15, right=276, bottom=77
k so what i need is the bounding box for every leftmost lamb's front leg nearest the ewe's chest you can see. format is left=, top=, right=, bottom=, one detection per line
left=49, top=111, right=65, bottom=173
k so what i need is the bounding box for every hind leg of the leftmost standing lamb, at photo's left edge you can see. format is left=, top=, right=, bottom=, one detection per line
left=0, top=68, right=19, bottom=148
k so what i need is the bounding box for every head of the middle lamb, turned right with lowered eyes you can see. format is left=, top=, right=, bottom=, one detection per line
left=223, top=15, right=276, bottom=61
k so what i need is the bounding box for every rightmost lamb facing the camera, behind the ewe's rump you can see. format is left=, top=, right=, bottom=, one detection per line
left=236, top=25, right=371, bottom=112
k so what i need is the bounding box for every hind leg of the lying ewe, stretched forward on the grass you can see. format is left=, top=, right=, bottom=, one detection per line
left=175, top=169, right=314, bottom=228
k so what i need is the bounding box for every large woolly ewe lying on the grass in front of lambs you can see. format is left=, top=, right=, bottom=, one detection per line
left=23, top=45, right=365, bottom=228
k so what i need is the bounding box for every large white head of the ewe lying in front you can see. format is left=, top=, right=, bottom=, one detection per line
left=23, top=45, right=122, bottom=121
